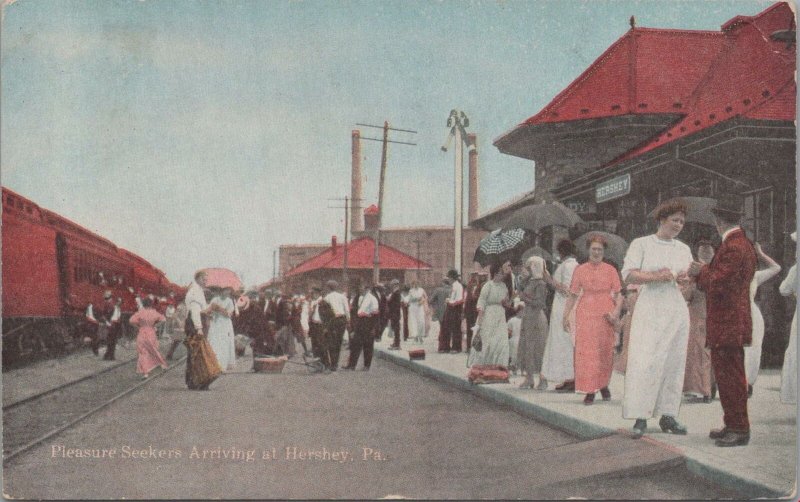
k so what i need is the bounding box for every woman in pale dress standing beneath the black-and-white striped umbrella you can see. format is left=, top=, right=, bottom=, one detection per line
left=468, top=262, right=511, bottom=366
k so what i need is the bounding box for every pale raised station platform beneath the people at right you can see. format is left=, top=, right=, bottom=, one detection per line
left=375, top=336, right=797, bottom=498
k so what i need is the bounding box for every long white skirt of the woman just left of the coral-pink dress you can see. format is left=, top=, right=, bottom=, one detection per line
left=542, top=294, right=575, bottom=382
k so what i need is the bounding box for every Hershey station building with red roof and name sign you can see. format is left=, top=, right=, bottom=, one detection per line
left=488, top=2, right=797, bottom=364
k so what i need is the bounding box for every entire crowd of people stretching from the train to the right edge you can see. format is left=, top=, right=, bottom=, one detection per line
left=79, top=195, right=797, bottom=446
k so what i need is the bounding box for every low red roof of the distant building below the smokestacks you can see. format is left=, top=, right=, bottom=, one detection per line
left=286, top=237, right=431, bottom=277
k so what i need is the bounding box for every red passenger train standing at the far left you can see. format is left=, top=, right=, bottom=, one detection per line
left=2, top=187, right=174, bottom=367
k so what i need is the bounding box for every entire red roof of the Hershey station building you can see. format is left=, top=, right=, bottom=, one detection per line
left=494, top=2, right=796, bottom=172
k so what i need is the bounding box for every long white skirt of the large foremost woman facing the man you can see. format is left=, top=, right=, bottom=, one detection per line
left=622, top=285, right=689, bottom=419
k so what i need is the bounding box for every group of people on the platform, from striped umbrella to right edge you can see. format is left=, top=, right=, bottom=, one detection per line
left=462, top=198, right=797, bottom=447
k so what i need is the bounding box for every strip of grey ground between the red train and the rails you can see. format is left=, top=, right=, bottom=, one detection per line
left=2, top=337, right=178, bottom=408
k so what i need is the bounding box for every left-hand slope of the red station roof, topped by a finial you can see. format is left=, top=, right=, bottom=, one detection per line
left=522, top=28, right=723, bottom=126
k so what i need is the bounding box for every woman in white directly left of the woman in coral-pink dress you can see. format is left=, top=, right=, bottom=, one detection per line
left=542, top=239, right=578, bottom=392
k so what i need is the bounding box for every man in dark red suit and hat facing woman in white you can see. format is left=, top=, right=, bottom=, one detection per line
left=689, top=196, right=758, bottom=446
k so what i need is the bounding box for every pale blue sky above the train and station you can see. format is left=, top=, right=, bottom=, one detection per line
left=0, top=0, right=772, bottom=284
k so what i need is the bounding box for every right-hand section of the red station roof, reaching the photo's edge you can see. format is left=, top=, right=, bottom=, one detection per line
left=609, top=2, right=796, bottom=165
